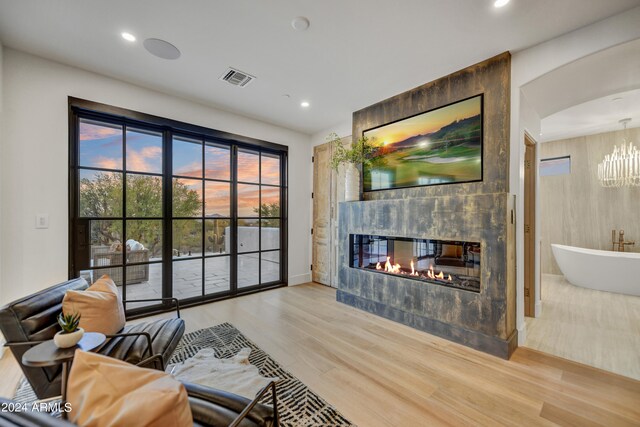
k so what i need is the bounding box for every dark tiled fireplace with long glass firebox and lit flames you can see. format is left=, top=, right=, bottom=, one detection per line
left=336, top=193, right=517, bottom=358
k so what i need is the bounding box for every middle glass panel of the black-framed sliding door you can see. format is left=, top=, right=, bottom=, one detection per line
left=172, top=136, right=234, bottom=299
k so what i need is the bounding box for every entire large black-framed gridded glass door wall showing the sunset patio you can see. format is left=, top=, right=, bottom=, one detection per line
left=69, top=98, right=287, bottom=314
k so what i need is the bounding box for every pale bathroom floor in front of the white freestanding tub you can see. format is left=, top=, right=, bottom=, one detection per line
left=525, top=274, right=640, bottom=380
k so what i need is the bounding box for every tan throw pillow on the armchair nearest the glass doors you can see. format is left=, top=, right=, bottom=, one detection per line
left=62, top=275, right=126, bottom=335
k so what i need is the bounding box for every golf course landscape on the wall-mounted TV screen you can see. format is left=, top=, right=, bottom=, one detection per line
left=363, top=95, right=482, bottom=191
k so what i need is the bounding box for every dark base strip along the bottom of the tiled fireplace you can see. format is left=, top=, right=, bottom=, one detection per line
left=336, top=289, right=518, bottom=359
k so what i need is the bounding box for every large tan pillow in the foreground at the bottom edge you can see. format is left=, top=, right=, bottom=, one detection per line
left=67, top=350, right=193, bottom=427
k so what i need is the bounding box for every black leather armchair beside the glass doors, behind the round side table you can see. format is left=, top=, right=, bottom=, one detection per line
left=0, top=278, right=184, bottom=399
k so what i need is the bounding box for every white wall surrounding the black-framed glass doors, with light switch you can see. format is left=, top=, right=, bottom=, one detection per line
left=0, top=48, right=311, bottom=302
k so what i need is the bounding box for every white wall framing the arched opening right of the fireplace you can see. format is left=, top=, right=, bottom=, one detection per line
left=509, top=7, right=640, bottom=344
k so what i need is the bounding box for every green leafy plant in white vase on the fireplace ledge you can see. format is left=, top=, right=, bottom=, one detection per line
left=327, top=132, right=380, bottom=202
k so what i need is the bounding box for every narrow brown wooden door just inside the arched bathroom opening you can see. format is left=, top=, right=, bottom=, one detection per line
left=524, top=135, right=537, bottom=317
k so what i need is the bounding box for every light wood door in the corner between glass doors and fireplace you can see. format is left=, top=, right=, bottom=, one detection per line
left=311, top=143, right=335, bottom=286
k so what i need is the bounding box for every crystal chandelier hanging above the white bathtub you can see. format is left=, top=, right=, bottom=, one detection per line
left=598, top=119, right=640, bottom=187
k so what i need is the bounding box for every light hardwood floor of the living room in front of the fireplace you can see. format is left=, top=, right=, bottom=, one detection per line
left=0, top=284, right=640, bottom=426
